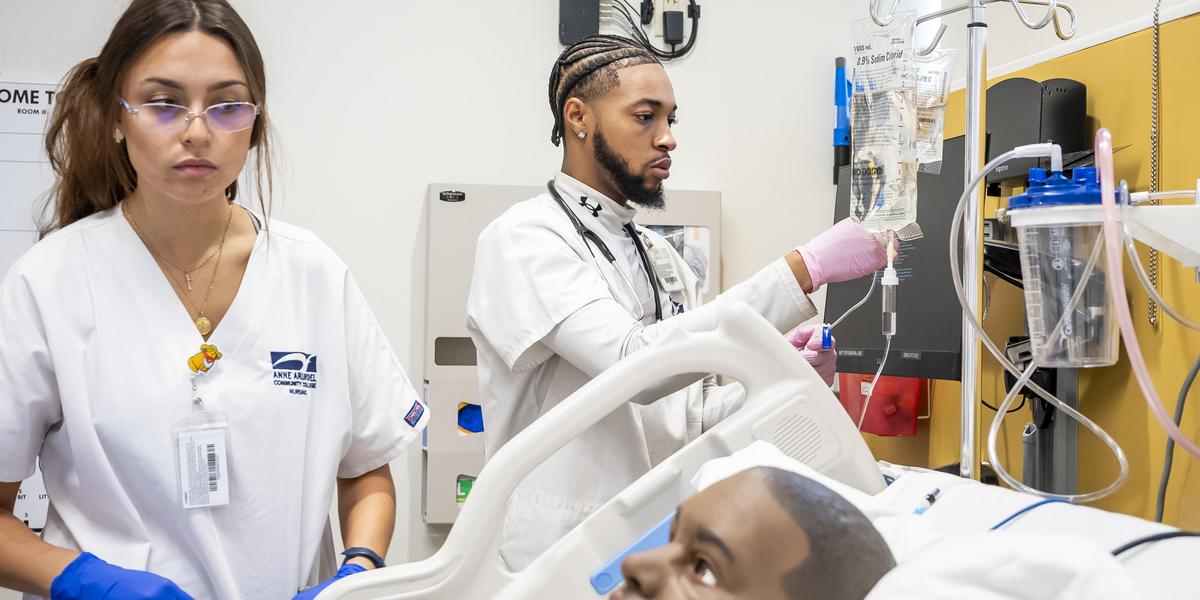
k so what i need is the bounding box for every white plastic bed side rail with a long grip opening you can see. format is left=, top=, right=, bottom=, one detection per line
left=319, top=304, right=883, bottom=600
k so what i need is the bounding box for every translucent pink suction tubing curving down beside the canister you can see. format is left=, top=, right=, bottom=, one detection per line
left=1096, top=128, right=1200, bottom=457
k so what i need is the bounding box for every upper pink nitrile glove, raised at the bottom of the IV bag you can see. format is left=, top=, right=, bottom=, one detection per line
left=796, top=217, right=888, bottom=290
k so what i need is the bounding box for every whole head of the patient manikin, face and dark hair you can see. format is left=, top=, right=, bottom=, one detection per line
left=611, top=467, right=895, bottom=600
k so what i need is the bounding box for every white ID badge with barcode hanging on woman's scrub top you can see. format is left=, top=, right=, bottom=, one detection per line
left=172, top=409, right=230, bottom=509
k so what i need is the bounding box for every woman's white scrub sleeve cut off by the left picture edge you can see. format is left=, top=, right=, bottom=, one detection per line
left=0, top=266, right=62, bottom=484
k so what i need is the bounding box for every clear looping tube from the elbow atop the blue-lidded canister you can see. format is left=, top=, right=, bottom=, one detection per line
left=950, top=144, right=1129, bottom=502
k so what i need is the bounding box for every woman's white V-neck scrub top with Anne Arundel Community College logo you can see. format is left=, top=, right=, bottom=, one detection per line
left=0, top=209, right=428, bottom=600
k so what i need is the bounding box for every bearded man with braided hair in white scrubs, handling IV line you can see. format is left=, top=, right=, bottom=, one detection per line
left=468, top=36, right=886, bottom=569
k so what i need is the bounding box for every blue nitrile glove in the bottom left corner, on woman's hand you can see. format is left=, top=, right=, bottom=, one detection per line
left=50, top=552, right=192, bottom=600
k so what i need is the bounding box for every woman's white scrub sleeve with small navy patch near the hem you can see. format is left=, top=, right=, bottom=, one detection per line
left=337, top=271, right=430, bottom=479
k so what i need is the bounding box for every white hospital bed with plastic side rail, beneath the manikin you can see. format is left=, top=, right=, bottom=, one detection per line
left=319, top=305, right=1200, bottom=600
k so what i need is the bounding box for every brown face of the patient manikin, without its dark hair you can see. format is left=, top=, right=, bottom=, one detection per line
left=611, top=470, right=810, bottom=600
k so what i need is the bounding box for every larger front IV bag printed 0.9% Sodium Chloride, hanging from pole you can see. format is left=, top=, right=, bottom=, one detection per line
left=850, top=12, right=918, bottom=232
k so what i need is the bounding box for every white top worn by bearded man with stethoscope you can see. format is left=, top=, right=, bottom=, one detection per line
left=467, top=173, right=816, bottom=569
